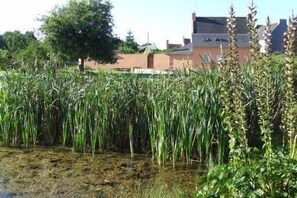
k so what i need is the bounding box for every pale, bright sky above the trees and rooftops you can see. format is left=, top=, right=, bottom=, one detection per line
left=0, top=0, right=297, bottom=49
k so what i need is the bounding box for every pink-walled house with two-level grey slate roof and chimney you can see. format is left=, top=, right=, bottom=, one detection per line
left=169, top=13, right=250, bottom=68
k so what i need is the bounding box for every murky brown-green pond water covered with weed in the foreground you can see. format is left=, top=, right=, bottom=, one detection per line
left=0, top=147, right=198, bottom=198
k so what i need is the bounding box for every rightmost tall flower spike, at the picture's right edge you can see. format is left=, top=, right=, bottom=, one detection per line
left=282, top=17, right=297, bottom=158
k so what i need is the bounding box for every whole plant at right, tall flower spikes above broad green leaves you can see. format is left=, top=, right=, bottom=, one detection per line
left=197, top=3, right=297, bottom=197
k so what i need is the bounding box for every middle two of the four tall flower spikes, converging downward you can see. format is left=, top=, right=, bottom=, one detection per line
left=248, top=6, right=274, bottom=158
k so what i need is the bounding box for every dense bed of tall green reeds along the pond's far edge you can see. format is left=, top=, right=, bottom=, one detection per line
left=0, top=55, right=292, bottom=166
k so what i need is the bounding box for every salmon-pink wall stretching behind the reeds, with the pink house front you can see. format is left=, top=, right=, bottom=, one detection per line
left=85, top=47, right=250, bottom=70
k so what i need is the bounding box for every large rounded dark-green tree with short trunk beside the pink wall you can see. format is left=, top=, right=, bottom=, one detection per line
left=41, top=0, right=117, bottom=71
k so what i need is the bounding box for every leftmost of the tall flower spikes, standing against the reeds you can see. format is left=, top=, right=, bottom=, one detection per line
left=220, top=6, right=248, bottom=159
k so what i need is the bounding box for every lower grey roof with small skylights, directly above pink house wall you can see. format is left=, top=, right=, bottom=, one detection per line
left=192, top=34, right=249, bottom=47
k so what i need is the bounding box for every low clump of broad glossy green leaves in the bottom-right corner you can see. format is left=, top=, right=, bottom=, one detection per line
left=196, top=151, right=297, bottom=198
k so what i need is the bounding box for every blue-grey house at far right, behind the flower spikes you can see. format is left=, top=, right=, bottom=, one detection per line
left=257, top=19, right=288, bottom=53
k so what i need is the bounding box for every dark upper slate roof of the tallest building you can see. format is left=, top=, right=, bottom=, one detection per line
left=193, top=17, right=249, bottom=34
